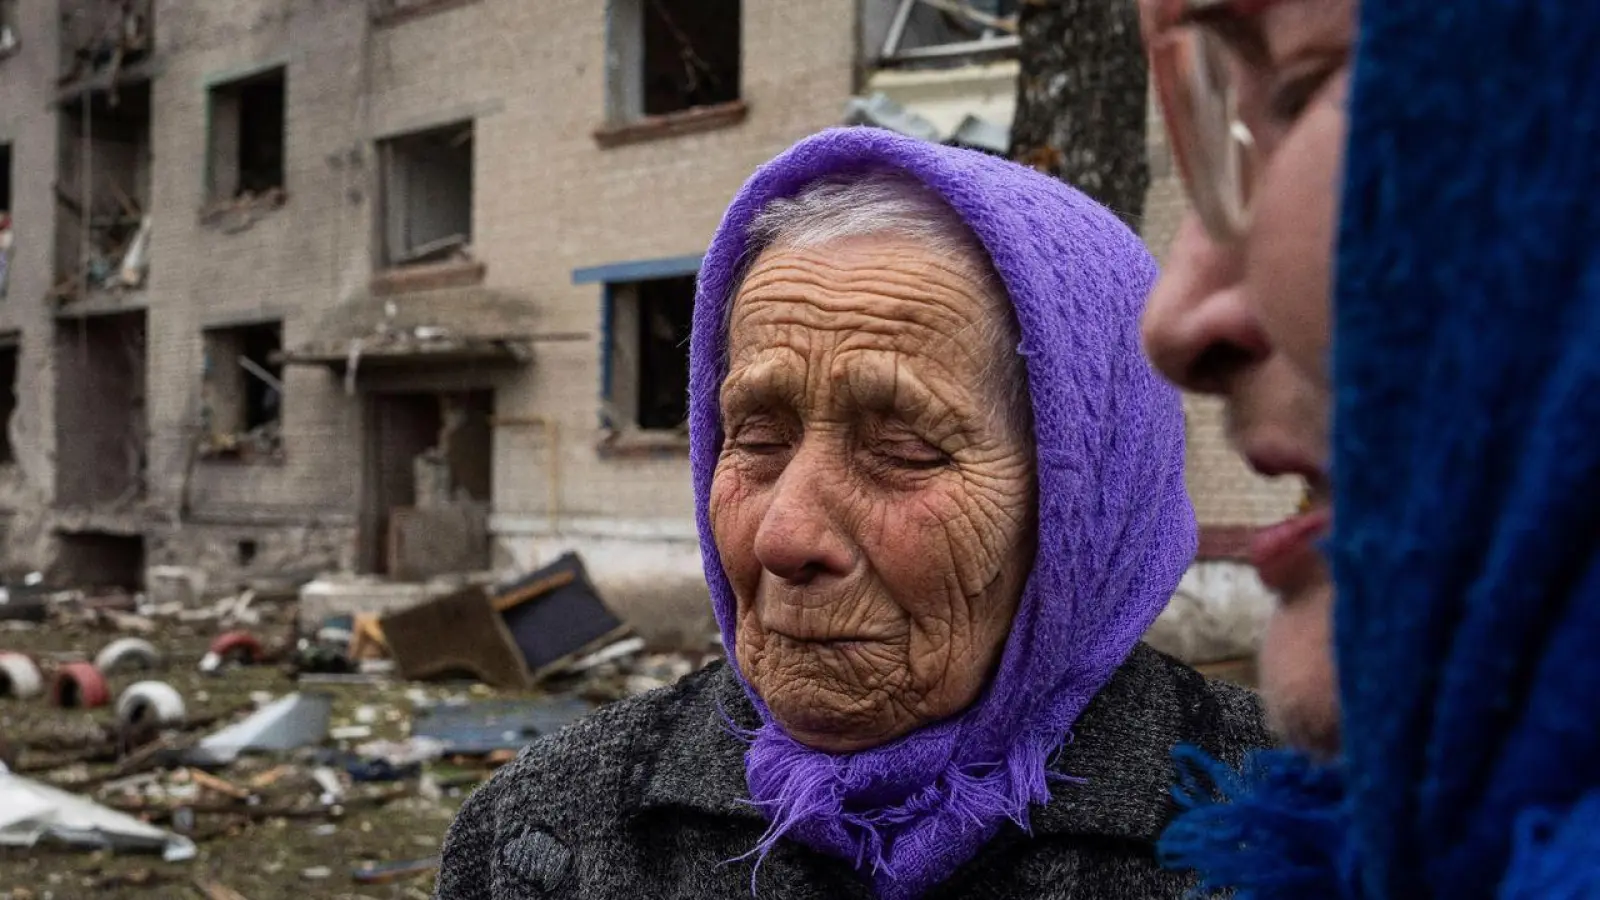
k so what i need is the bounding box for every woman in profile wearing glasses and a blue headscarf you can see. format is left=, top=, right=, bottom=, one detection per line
left=1144, top=0, right=1600, bottom=900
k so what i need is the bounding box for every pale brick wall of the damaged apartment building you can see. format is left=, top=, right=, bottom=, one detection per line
left=0, top=0, right=1286, bottom=589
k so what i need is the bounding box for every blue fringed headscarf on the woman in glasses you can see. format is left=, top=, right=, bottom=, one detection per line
left=1163, top=0, right=1600, bottom=900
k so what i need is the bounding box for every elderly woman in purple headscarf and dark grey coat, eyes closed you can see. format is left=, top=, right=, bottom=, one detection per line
left=438, top=128, right=1267, bottom=900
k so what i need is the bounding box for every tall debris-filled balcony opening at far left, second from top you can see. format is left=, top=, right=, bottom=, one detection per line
left=51, top=82, right=152, bottom=301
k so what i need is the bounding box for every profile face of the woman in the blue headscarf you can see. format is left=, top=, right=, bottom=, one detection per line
left=1144, top=0, right=1355, bottom=753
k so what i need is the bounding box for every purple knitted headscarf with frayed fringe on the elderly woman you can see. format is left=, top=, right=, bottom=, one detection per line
left=690, top=128, right=1195, bottom=898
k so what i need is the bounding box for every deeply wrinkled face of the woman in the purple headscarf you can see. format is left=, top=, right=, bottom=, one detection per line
left=710, top=230, right=1034, bottom=753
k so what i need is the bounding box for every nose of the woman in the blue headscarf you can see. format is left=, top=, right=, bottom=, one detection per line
left=1141, top=215, right=1270, bottom=394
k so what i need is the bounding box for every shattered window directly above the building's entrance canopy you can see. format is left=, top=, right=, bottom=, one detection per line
left=381, top=122, right=472, bottom=266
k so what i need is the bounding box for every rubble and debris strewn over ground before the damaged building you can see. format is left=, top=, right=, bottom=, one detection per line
left=0, top=556, right=722, bottom=900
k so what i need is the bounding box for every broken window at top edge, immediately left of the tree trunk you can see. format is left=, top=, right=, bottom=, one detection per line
left=862, top=0, right=1021, bottom=64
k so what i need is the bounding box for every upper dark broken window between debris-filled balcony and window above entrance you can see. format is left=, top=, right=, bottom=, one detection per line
left=210, top=69, right=286, bottom=202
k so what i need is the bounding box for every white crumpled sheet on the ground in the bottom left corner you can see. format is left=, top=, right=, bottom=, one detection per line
left=0, top=765, right=195, bottom=862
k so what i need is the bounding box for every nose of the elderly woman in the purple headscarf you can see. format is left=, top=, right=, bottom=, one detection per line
left=755, top=450, right=856, bottom=583
